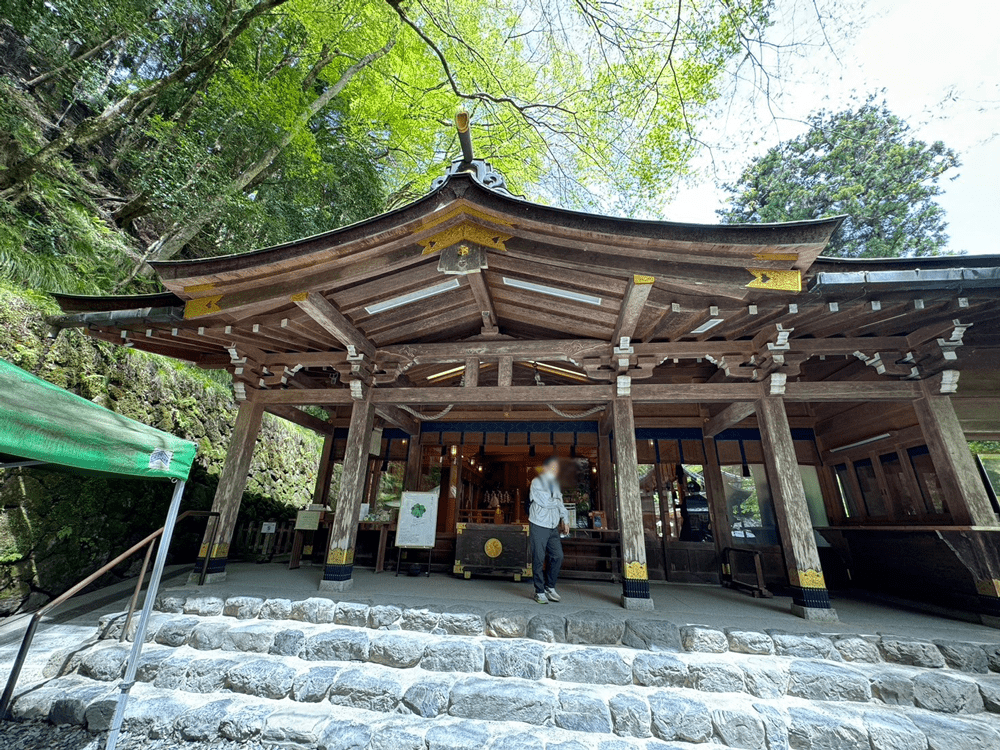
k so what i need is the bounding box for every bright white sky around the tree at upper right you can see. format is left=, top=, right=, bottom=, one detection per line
left=663, top=0, right=1000, bottom=253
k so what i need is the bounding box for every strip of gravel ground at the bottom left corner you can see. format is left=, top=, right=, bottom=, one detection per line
left=0, top=721, right=264, bottom=750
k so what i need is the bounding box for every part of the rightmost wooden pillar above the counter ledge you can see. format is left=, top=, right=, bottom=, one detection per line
left=913, top=384, right=997, bottom=527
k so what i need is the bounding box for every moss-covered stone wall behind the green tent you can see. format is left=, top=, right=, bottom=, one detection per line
left=0, top=287, right=322, bottom=616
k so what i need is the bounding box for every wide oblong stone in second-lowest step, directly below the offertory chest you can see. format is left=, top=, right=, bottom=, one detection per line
left=448, top=677, right=558, bottom=725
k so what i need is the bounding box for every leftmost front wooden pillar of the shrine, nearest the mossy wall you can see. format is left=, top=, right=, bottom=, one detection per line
left=191, top=401, right=264, bottom=583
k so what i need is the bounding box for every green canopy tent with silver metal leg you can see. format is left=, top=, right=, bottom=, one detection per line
left=0, top=359, right=197, bottom=748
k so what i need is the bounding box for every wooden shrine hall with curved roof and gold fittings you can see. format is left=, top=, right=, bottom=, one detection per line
left=50, top=125, right=1000, bottom=624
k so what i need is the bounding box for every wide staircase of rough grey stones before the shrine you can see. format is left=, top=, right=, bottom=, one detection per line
left=7, top=595, right=1000, bottom=750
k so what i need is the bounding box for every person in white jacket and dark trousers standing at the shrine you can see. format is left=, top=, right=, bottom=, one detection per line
left=528, top=456, right=569, bottom=604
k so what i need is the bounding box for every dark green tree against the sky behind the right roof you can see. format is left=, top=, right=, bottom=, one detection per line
left=718, top=97, right=959, bottom=258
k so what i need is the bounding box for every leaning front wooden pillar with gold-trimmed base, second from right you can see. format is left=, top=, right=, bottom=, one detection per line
left=757, top=396, right=837, bottom=622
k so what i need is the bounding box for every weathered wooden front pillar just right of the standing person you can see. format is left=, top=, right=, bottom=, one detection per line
left=612, top=396, right=653, bottom=609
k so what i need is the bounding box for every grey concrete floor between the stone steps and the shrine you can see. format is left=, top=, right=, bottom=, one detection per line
left=156, top=563, right=1000, bottom=643
